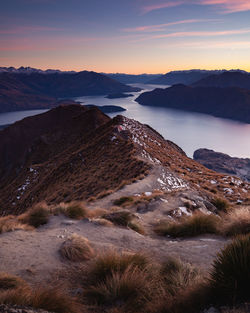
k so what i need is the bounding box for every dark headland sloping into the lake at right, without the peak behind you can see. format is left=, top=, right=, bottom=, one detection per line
left=136, top=85, right=250, bottom=123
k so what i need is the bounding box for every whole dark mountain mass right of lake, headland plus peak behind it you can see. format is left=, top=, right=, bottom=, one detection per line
left=136, top=72, right=250, bottom=123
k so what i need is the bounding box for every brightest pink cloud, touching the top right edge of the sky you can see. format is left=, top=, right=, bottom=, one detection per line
left=141, top=0, right=250, bottom=14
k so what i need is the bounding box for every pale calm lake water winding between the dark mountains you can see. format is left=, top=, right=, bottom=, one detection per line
left=0, top=84, right=250, bottom=158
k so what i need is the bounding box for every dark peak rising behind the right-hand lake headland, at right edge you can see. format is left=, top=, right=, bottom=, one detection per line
left=193, top=72, right=250, bottom=90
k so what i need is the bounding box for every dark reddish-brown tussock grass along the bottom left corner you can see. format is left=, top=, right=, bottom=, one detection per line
left=0, top=287, right=80, bottom=313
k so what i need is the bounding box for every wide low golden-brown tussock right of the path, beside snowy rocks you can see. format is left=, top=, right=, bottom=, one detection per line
left=154, top=213, right=219, bottom=237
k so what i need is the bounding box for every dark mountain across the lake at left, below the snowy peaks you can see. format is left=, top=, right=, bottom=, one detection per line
left=0, top=71, right=140, bottom=112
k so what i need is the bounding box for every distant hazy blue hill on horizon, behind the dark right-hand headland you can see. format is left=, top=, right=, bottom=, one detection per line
left=147, top=70, right=226, bottom=86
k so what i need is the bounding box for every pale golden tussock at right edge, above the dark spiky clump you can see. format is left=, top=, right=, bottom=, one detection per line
left=221, top=207, right=250, bottom=236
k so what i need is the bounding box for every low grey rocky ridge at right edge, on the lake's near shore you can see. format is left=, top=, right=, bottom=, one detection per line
left=194, top=149, right=250, bottom=182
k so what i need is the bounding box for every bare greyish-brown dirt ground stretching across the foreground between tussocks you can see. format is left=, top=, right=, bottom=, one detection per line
left=0, top=216, right=229, bottom=282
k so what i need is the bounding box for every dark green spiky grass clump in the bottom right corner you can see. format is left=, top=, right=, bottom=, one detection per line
left=211, top=235, right=250, bottom=304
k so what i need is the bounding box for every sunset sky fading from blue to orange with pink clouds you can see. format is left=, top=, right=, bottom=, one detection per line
left=0, top=0, right=250, bottom=74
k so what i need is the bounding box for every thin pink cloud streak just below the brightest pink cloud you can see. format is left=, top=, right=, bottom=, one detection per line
left=123, top=19, right=219, bottom=33
